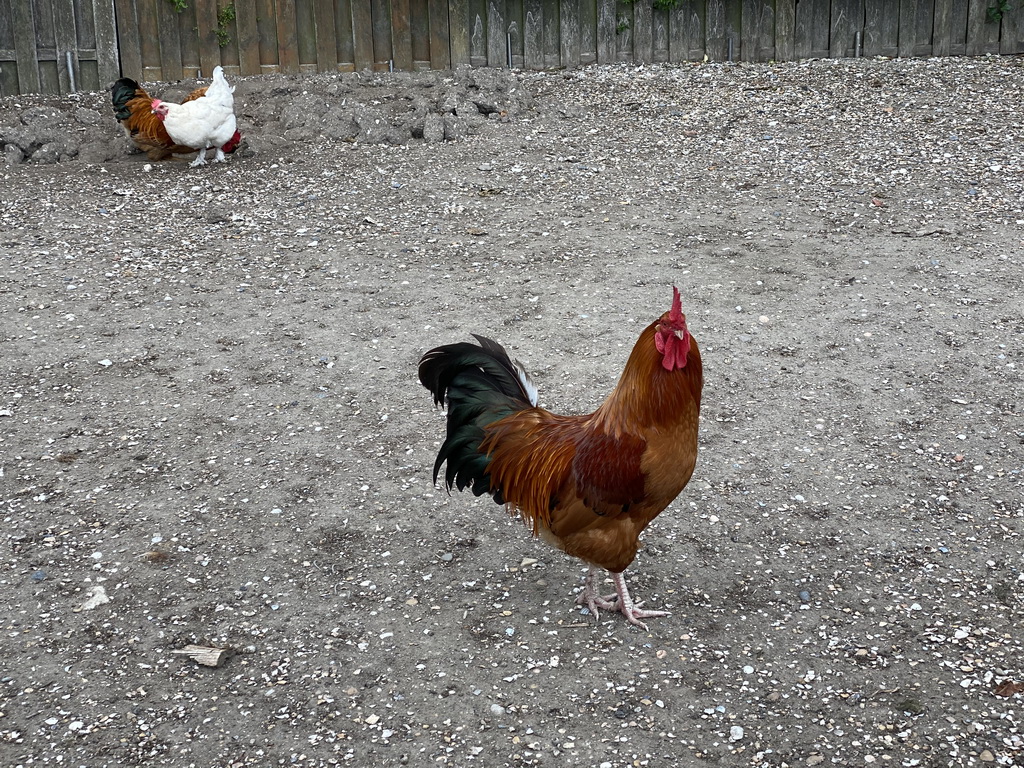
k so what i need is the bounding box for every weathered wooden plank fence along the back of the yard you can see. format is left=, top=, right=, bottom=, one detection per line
left=0, top=0, right=1024, bottom=95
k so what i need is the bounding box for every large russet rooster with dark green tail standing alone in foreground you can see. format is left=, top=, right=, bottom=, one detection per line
left=419, top=288, right=703, bottom=630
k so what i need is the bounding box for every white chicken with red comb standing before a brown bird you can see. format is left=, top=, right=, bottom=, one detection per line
left=153, top=67, right=236, bottom=167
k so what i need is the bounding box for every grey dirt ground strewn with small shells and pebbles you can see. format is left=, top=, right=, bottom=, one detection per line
left=0, top=57, right=1024, bottom=768
